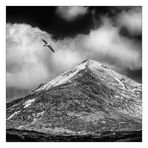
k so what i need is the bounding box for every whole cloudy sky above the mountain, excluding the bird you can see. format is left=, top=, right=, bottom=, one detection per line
left=6, top=6, right=142, bottom=90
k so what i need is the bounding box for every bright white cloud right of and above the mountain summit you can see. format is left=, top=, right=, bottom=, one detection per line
left=74, top=18, right=142, bottom=70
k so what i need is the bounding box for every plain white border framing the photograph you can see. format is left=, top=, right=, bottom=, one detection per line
left=0, top=0, right=148, bottom=148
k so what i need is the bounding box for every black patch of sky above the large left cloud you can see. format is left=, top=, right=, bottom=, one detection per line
left=6, top=6, right=93, bottom=39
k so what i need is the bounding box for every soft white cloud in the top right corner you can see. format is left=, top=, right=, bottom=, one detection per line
left=117, top=7, right=142, bottom=34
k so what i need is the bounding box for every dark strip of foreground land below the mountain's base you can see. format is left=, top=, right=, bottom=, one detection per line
left=6, top=129, right=142, bottom=142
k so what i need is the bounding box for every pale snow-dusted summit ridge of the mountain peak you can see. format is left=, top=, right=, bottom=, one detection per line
left=35, top=59, right=137, bottom=91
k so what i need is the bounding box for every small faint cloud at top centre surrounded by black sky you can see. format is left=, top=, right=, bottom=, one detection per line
left=56, top=6, right=88, bottom=21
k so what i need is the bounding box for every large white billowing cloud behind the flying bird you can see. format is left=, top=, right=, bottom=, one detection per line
left=6, top=24, right=81, bottom=88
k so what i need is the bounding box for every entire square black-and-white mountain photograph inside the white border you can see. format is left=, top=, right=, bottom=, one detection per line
left=5, top=5, right=143, bottom=142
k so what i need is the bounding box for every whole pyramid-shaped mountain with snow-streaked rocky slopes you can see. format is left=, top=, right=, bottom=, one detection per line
left=7, top=60, right=142, bottom=140
